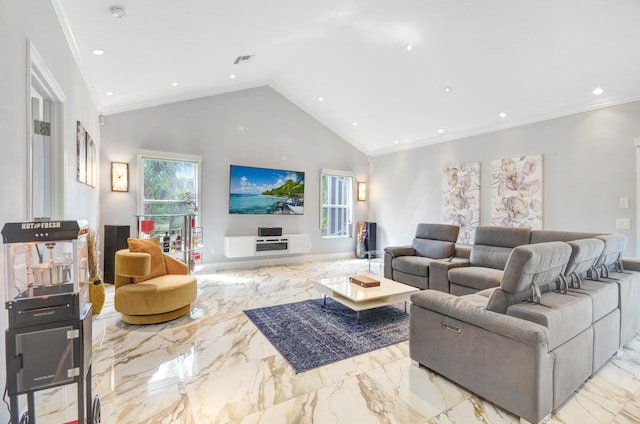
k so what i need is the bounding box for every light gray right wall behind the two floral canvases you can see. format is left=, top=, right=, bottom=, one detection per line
left=370, top=102, right=640, bottom=256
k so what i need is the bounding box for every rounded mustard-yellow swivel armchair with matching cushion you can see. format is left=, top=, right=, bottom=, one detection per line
left=114, top=238, right=198, bottom=324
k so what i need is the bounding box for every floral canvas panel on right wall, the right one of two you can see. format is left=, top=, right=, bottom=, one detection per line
left=491, top=155, right=542, bottom=230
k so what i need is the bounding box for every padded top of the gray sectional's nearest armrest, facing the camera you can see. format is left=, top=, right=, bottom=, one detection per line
left=411, top=290, right=549, bottom=346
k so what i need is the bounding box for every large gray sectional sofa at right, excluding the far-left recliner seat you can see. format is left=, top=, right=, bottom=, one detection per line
left=408, top=227, right=640, bottom=422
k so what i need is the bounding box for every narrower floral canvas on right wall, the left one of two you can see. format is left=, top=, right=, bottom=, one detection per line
left=442, top=162, right=480, bottom=244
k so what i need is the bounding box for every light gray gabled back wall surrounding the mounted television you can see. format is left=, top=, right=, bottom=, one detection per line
left=100, top=87, right=369, bottom=262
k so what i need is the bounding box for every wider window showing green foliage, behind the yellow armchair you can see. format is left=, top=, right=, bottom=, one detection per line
left=138, top=153, right=201, bottom=214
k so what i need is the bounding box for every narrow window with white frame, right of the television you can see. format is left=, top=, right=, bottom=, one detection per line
left=320, top=170, right=354, bottom=237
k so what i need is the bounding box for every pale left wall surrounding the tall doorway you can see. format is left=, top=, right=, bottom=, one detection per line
left=0, top=0, right=100, bottom=422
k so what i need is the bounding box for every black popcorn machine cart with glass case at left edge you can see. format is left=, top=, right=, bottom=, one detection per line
left=2, top=220, right=100, bottom=424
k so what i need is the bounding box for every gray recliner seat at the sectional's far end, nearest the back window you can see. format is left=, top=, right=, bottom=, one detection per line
left=384, top=223, right=460, bottom=289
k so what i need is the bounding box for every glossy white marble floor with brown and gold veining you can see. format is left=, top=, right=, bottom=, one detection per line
left=31, top=259, right=640, bottom=424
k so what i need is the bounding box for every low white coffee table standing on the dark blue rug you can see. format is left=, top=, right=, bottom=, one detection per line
left=313, top=275, right=420, bottom=322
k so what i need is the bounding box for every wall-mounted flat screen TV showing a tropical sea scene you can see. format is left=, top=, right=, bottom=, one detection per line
left=229, top=165, right=304, bottom=215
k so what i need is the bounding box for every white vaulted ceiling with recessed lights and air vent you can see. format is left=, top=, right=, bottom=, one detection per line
left=52, top=0, right=640, bottom=155
